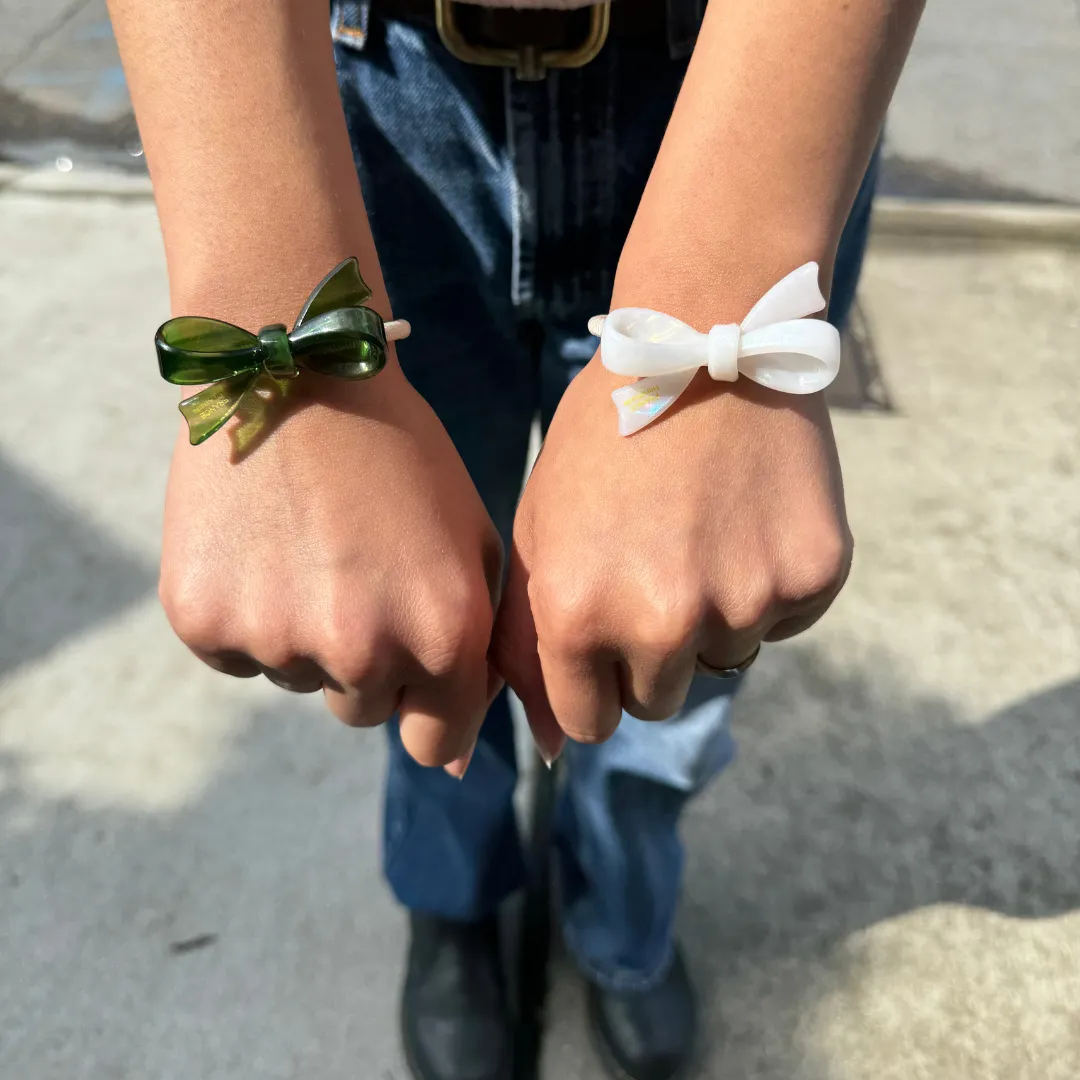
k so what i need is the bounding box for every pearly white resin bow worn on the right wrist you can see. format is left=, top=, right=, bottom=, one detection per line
left=589, top=262, right=840, bottom=435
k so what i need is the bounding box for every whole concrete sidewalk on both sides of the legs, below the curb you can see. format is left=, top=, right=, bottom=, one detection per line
left=0, top=172, right=1080, bottom=1080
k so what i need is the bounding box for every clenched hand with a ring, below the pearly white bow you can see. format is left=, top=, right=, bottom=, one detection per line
left=491, top=357, right=852, bottom=757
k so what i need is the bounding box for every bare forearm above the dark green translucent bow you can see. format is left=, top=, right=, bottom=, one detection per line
left=109, top=0, right=390, bottom=328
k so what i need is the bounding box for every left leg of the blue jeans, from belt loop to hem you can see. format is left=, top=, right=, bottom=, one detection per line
left=334, top=4, right=536, bottom=919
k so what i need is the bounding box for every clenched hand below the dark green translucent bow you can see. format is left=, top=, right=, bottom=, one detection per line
left=161, top=360, right=501, bottom=775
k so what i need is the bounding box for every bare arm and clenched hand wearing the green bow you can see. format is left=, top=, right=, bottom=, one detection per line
left=110, top=0, right=500, bottom=774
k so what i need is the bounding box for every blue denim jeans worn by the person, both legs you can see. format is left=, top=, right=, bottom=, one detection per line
left=332, top=0, right=873, bottom=989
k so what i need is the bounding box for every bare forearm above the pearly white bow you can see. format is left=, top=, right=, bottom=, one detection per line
left=612, top=0, right=922, bottom=328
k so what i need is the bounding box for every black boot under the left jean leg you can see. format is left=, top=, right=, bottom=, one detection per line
left=401, top=913, right=511, bottom=1080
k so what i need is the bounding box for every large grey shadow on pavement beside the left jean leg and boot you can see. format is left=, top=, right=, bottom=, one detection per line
left=0, top=687, right=405, bottom=1080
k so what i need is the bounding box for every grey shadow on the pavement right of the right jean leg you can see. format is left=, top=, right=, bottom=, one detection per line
left=681, top=647, right=1080, bottom=1080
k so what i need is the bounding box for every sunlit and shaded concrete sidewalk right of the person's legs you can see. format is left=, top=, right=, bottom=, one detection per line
left=545, top=243, right=1080, bottom=1080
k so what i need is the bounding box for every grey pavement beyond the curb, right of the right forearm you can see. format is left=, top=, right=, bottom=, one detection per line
left=883, top=0, right=1080, bottom=203
